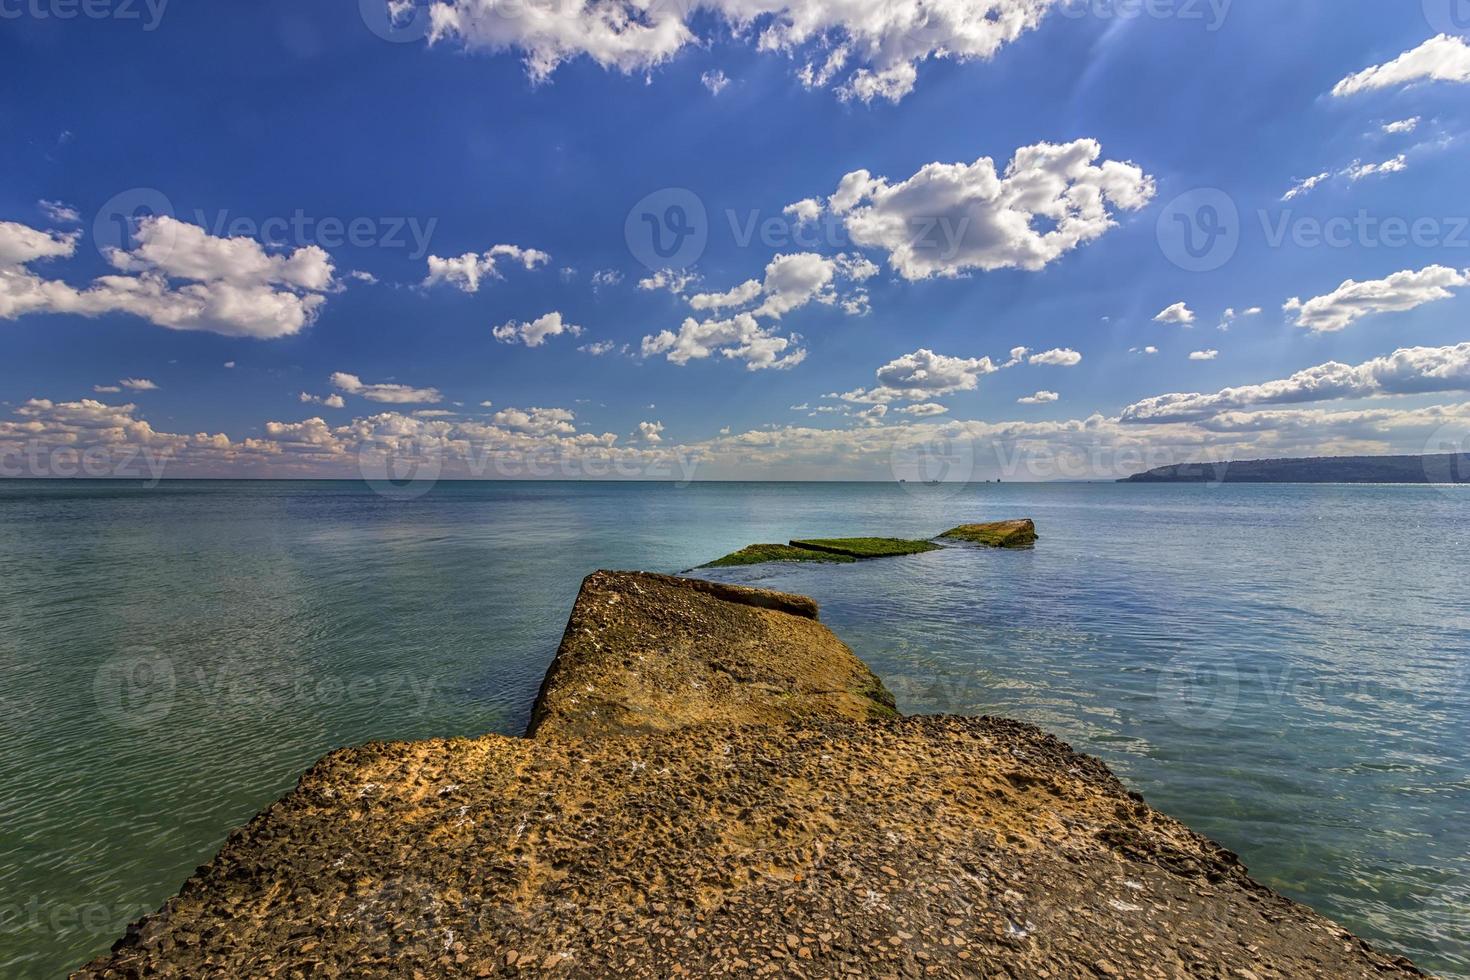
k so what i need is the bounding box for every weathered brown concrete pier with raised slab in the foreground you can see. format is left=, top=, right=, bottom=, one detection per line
left=76, top=572, right=1421, bottom=979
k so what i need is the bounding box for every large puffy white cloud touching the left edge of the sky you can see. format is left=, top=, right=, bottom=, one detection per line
left=0, top=216, right=335, bottom=339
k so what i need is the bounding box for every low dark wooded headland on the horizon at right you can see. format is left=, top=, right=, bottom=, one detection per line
left=1117, top=453, right=1470, bottom=483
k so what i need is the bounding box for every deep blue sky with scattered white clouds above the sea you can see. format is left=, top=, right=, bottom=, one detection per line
left=0, top=0, right=1470, bottom=482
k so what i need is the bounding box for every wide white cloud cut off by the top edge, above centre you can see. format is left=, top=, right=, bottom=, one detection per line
left=426, top=0, right=1054, bottom=101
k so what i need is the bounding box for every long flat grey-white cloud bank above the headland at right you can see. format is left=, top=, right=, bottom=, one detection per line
left=1120, top=342, right=1470, bottom=423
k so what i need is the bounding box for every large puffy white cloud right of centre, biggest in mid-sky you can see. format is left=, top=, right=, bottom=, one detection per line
left=828, top=140, right=1154, bottom=279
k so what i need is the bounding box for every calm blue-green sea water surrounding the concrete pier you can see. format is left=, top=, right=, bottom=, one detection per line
left=0, top=482, right=1470, bottom=977
